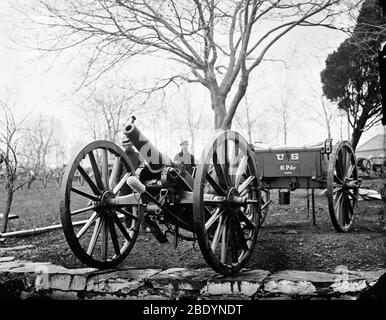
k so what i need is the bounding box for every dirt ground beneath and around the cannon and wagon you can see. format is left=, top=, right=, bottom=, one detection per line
left=0, top=180, right=386, bottom=272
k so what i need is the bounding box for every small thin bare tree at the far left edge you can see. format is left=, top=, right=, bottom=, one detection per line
left=0, top=101, right=26, bottom=233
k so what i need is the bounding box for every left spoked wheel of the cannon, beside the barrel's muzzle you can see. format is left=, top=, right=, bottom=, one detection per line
left=60, top=141, right=140, bottom=269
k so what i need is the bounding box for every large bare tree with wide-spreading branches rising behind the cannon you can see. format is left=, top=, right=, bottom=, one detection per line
left=24, top=0, right=360, bottom=129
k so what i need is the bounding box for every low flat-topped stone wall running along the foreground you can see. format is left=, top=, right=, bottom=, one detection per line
left=0, top=257, right=386, bottom=300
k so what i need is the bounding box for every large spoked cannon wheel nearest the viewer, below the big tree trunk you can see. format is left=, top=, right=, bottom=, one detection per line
left=193, top=131, right=260, bottom=274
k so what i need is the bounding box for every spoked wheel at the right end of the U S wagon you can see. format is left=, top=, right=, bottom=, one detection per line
left=327, top=141, right=359, bottom=232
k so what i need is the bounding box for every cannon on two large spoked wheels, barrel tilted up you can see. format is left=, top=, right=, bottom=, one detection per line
left=60, top=118, right=260, bottom=274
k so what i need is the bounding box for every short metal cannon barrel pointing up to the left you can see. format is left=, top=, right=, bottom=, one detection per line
left=124, top=123, right=172, bottom=172
